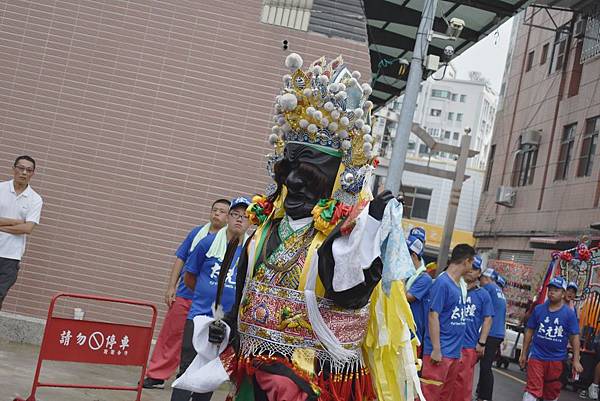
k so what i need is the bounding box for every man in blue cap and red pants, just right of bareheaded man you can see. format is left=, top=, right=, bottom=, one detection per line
left=448, top=255, right=494, bottom=401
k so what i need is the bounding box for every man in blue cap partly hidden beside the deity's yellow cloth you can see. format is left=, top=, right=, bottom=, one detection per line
left=406, top=231, right=433, bottom=350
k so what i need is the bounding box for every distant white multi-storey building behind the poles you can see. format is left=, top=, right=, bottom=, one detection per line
left=378, top=70, right=498, bottom=231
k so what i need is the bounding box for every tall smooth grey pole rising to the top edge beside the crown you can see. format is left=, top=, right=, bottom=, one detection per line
left=385, top=0, right=437, bottom=194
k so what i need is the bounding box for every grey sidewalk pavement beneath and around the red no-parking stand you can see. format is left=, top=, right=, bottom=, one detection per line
left=0, top=340, right=227, bottom=401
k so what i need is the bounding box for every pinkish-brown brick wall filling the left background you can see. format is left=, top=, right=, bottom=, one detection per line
left=0, top=0, right=370, bottom=324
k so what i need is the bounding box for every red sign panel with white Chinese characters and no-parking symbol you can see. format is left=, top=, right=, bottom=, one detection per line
left=41, top=318, right=152, bottom=365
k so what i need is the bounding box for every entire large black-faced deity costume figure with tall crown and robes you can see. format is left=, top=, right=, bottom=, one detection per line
left=174, top=54, right=420, bottom=401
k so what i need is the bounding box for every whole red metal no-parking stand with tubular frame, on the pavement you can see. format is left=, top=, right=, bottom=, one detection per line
left=14, top=294, right=156, bottom=401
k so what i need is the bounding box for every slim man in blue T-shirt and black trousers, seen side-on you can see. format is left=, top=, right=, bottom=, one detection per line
left=477, top=269, right=506, bottom=400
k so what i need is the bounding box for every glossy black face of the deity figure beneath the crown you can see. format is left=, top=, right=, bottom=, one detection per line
left=275, top=143, right=340, bottom=219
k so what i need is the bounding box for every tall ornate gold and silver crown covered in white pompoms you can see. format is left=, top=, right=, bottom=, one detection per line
left=268, top=53, right=376, bottom=204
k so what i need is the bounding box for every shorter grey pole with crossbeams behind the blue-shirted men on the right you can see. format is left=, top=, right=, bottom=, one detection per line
left=437, top=128, right=471, bottom=275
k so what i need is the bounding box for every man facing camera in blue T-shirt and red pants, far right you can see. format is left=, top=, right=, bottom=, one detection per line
left=519, top=276, right=583, bottom=401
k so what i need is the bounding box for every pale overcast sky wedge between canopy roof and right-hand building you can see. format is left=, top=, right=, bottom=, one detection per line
left=452, top=18, right=512, bottom=93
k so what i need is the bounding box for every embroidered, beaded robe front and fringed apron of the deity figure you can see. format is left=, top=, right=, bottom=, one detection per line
left=233, top=218, right=376, bottom=401
